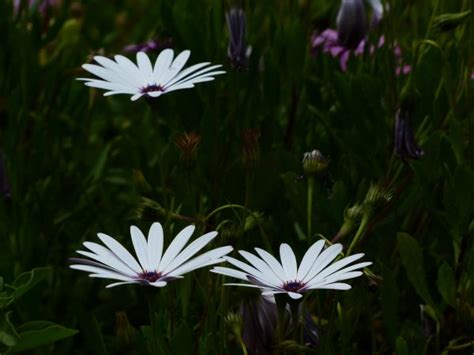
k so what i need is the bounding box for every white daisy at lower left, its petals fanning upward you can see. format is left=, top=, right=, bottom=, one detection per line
left=70, top=222, right=233, bottom=287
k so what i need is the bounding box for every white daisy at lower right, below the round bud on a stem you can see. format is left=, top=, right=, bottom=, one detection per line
left=211, top=240, right=372, bottom=299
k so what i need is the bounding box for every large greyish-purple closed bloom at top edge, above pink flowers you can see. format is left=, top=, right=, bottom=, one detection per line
left=337, top=0, right=367, bottom=49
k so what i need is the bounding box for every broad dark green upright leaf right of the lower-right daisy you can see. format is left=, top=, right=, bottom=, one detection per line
left=397, top=233, right=433, bottom=304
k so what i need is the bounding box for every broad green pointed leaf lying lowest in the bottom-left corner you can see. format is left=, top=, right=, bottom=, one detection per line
left=10, top=321, right=78, bottom=352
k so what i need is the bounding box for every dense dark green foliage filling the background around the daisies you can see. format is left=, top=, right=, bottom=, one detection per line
left=0, top=0, right=474, bottom=355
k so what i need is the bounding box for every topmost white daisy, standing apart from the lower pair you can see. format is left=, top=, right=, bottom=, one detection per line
left=78, top=48, right=225, bottom=101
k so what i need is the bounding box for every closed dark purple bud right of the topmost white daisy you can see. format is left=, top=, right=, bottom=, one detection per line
left=225, top=8, right=252, bottom=69
